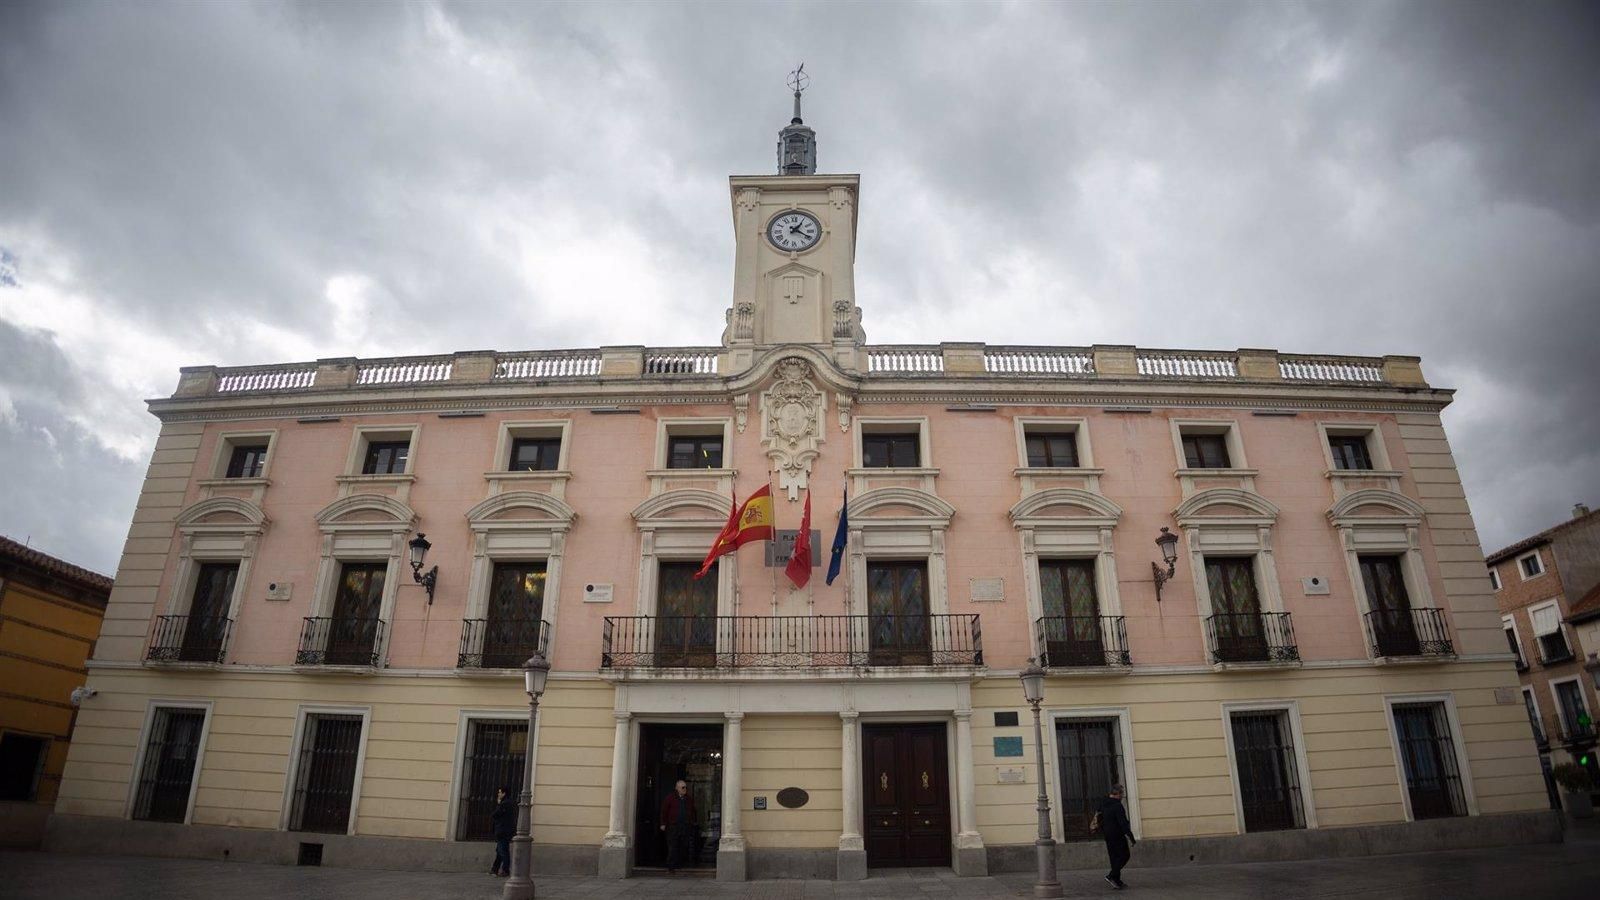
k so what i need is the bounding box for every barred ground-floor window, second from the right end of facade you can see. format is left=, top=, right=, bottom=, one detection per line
left=1229, top=709, right=1306, bottom=831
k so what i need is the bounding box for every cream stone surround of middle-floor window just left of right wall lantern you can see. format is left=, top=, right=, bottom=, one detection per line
left=1006, top=486, right=1123, bottom=656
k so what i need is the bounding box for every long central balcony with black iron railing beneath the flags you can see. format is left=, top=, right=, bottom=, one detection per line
left=600, top=615, right=984, bottom=673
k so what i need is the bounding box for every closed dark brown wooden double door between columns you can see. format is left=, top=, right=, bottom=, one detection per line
left=861, top=724, right=950, bottom=868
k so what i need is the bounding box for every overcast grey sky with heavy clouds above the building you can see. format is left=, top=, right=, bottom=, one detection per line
left=0, top=0, right=1600, bottom=572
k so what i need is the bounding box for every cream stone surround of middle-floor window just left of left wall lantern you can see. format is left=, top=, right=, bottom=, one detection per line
left=306, top=493, right=416, bottom=671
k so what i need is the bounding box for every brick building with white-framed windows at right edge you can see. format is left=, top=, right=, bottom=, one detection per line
left=1485, top=503, right=1600, bottom=796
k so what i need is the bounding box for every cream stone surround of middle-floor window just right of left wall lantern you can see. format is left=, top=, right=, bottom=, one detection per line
left=462, top=490, right=578, bottom=645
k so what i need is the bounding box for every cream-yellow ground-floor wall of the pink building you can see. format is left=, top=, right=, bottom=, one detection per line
left=56, top=661, right=1546, bottom=854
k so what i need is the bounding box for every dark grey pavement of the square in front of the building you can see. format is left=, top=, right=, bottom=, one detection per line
left=0, top=836, right=1600, bottom=900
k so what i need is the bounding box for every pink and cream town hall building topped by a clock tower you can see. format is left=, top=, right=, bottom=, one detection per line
left=50, top=87, right=1558, bottom=879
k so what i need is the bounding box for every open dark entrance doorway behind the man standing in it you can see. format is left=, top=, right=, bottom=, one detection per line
left=634, top=724, right=722, bottom=868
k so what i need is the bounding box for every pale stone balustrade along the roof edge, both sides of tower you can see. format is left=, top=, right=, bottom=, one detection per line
left=173, top=343, right=1427, bottom=399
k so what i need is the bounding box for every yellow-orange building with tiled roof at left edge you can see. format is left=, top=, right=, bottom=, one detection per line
left=0, top=538, right=112, bottom=847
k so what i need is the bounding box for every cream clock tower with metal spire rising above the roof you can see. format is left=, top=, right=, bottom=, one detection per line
left=722, top=66, right=866, bottom=372
